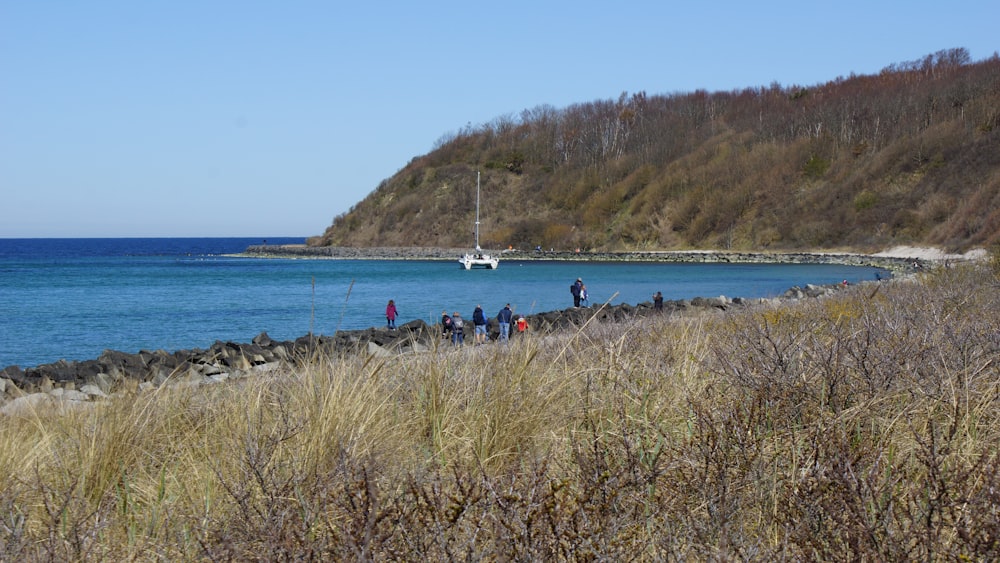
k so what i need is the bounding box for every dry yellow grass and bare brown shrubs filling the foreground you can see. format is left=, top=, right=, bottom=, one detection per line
left=0, top=266, right=1000, bottom=561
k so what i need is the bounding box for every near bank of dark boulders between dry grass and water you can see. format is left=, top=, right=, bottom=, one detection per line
left=0, top=282, right=867, bottom=415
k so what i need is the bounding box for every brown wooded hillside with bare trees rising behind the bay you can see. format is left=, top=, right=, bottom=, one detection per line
left=309, top=48, right=1000, bottom=251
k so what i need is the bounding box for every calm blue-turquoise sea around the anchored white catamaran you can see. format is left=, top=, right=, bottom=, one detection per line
left=0, top=237, right=876, bottom=368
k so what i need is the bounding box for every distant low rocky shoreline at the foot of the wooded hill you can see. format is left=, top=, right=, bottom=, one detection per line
left=240, top=244, right=966, bottom=272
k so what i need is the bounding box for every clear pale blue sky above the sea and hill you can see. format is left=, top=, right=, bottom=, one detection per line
left=0, top=0, right=1000, bottom=237
